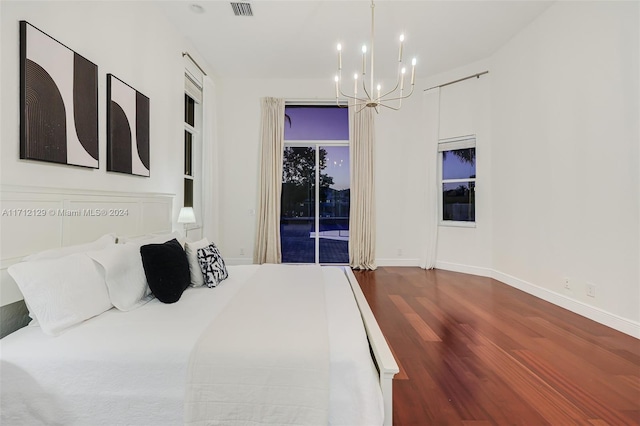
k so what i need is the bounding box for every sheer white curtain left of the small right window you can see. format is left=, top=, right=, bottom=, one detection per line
left=420, top=87, right=440, bottom=269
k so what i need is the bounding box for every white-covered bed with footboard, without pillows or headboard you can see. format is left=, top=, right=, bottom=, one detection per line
left=0, top=233, right=398, bottom=425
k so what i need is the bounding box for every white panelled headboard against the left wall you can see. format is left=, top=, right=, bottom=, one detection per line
left=0, top=185, right=174, bottom=337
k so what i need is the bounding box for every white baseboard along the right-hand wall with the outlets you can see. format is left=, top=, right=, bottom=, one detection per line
left=491, top=270, right=640, bottom=339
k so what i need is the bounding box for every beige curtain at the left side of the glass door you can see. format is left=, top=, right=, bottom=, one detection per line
left=253, top=98, right=284, bottom=263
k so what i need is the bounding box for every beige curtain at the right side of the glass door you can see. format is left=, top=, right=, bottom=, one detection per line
left=349, top=107, right=376, bottom=269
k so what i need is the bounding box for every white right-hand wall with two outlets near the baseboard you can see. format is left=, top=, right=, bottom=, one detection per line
left=491, top=2, right=640, bottom=334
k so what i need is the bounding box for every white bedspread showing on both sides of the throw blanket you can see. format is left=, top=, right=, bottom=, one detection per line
left=0, top=265, right=384, bottom=425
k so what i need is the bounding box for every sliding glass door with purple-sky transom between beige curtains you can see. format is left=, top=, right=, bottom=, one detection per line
left=280, top=106, right=350, bottom=264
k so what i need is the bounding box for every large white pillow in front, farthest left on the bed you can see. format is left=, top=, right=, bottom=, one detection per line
left=8, top=253, right=112, bottom=336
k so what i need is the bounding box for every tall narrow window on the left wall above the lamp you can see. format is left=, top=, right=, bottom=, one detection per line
left=183, top=71, right=202, bottom=223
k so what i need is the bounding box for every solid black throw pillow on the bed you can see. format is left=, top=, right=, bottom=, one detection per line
left=140, top=238, right=191, bottom=303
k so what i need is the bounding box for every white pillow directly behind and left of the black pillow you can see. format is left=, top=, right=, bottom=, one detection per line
left=87, top=243, right=153, bottom=311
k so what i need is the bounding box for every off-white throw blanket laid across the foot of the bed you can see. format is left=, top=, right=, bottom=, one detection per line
left=185, top=265, right=329, bottom=426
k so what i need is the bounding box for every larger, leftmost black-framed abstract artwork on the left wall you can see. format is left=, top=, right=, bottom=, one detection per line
left=20, top=21, right=100, bottom=169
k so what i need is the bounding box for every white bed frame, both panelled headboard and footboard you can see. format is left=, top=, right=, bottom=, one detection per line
left=0, top=185, right=399, bottom=425
